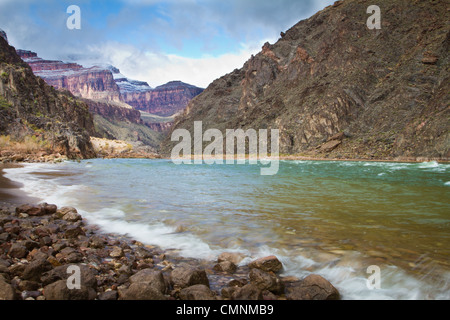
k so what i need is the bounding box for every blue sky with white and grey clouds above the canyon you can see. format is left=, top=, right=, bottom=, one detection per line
left=0, top=0, right=335, bottom=87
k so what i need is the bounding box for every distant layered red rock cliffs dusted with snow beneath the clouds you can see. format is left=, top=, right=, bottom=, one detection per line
left=17, top=50, right=203, bottom=116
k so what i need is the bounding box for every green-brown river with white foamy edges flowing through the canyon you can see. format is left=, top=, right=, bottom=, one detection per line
left=4, top=159, right=450, bottom=299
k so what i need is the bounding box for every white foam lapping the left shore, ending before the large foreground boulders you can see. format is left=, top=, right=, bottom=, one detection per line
left=4, top=164, right=227, bottom=259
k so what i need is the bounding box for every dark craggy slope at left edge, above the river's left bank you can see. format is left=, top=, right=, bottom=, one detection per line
left=0, top=37, right=95, bottom=158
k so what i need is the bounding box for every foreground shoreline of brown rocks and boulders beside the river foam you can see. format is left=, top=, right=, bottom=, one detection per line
left=0, top=203, right=340, bottom=300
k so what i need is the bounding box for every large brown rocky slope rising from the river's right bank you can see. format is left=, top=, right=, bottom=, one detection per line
left=162, top=0, right=450, bottom=159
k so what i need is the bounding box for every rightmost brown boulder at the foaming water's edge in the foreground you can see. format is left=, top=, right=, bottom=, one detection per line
left=286, top=274, right=340, bottom=300
